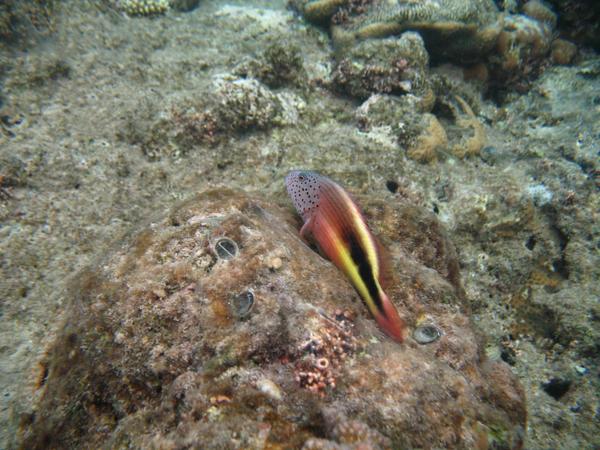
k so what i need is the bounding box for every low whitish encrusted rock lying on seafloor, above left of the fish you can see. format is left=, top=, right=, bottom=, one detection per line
left=119, top=75, right=305, bottom=161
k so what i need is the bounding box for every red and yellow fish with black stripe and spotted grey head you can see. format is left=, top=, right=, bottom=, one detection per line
left=285, top=170, right=407, bottom=343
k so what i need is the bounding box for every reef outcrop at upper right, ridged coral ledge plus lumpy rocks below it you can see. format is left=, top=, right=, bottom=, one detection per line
left=290, top=0, right=578, bottom=162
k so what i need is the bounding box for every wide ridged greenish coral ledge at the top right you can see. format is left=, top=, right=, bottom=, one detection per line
left=291, top=0, right=577, bottom=98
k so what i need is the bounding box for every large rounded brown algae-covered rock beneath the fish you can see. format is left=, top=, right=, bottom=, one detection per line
left=19, top=189, right=526, bottom=449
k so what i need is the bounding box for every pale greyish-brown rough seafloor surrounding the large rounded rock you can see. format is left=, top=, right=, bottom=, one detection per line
left=0, top=0, right=600, bottom=449
